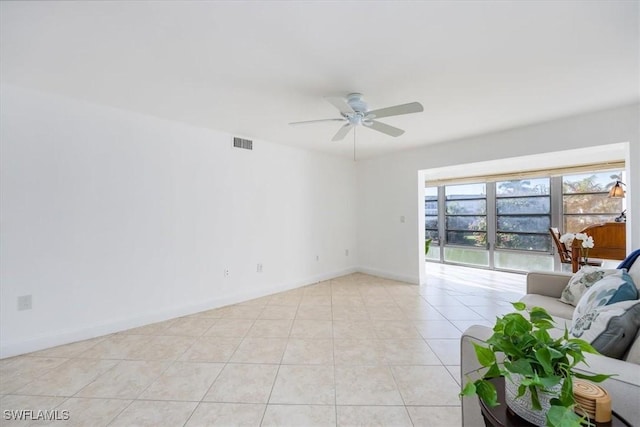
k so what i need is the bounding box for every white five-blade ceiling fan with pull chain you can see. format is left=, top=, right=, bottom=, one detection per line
left=289, top=93, right=424, bottom=141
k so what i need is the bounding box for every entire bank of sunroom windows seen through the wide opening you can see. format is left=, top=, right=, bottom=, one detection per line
left=425, top=164, right=625, bottom=271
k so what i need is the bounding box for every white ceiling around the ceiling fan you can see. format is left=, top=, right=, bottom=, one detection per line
left=0, top=0, right=640, bottom=158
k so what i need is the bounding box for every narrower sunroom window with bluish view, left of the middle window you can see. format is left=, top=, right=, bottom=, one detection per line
left=444, top=184, right=487, bottom=247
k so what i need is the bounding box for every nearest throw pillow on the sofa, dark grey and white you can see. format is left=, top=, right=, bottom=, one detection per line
left=571, top=300, right=640, bottom=359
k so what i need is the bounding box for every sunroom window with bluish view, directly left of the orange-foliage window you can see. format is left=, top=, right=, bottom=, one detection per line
left=496, top=178, right=551, bottom=252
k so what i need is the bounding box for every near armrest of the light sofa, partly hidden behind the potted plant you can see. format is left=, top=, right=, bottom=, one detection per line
left=460, top=325, right=640, bottom=427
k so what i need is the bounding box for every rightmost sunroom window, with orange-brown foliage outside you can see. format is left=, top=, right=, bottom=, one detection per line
left=562, top=171, right=623, bottom=233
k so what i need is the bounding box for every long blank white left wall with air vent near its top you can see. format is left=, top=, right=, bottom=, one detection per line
left=0, top=86, right=357, bottom=357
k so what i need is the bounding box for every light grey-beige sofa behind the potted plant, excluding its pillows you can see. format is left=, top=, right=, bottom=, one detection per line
left=460, top=270, right=640, bottom=427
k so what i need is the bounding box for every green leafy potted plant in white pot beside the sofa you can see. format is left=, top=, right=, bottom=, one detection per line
left=460, top=302, right=611, bottom=427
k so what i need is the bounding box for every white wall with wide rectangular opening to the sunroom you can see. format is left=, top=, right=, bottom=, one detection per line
left=357, top=104, right=640, bottom=283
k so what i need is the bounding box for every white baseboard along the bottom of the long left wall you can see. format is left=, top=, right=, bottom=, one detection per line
left=0, top=267, right=358, bottom=359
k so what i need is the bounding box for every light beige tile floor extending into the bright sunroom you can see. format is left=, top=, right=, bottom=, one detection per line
left=0, top=264, right=525, bottom=427
